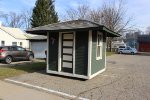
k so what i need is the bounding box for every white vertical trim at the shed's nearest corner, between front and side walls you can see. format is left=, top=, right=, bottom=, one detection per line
left=88, top=30, right=92, bottom=77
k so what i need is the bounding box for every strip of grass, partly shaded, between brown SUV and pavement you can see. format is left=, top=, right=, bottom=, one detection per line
left=0, top=62, right=46, bottom=79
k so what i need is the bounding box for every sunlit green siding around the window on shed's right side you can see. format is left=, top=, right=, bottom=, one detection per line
left=91, top=31, right=106, bottom=74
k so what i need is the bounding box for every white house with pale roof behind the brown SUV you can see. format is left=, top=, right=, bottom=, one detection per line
left=0, top=24, right=29, bottom=49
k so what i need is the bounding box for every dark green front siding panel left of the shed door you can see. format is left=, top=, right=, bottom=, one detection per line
left=48, top=33, right=59, bottom=71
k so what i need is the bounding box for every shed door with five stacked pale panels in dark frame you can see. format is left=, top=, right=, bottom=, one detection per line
left=61, top=32, right=74, bottom=73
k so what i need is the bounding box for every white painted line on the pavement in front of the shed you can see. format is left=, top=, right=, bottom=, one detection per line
left=5, top=79, right=89, bottom=100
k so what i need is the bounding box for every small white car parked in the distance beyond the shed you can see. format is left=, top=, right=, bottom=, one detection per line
left=118, top=46, right=137, bottom=55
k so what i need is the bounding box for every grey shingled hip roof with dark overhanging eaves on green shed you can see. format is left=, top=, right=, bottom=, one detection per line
left=26, top=20, right=121, bottom=37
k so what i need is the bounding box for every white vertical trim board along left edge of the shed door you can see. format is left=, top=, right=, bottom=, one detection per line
left=58, top=32, right=62, bottom=72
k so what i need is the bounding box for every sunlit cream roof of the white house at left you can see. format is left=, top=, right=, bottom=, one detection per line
left=0, top=26, right=27, bottom=39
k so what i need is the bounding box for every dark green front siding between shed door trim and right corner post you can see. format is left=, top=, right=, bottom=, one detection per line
left=75, top=31, right=88, bottom=75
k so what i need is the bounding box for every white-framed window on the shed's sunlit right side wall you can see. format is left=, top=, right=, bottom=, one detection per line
left=96, top=32, right=103, bottom=60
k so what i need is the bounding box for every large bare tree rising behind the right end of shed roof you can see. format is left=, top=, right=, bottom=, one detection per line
left=101, top=0, right=131, bottom=51
